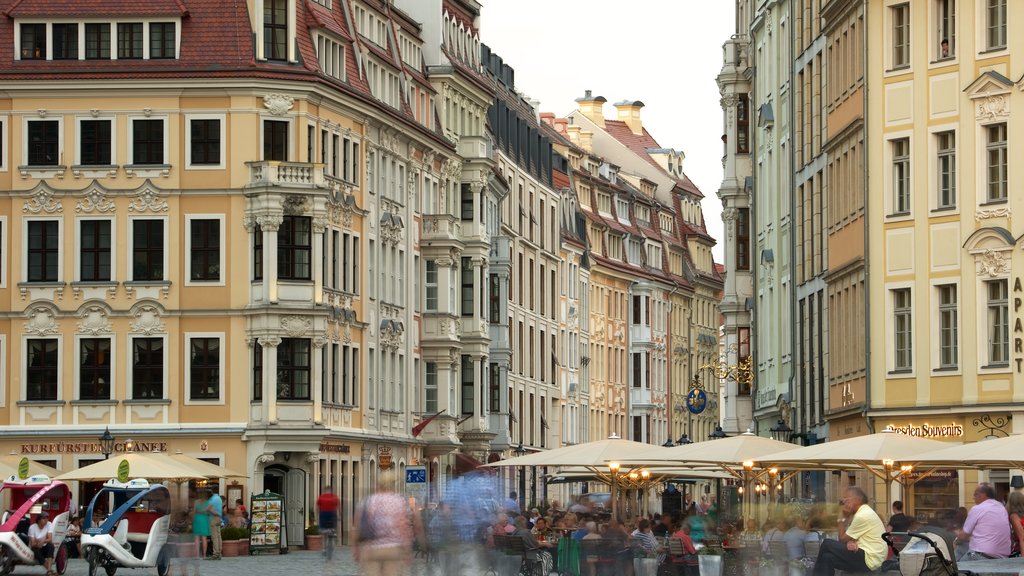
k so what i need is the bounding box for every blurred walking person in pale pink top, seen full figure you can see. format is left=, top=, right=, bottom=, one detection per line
left=352, top=471, right=423, bottom=576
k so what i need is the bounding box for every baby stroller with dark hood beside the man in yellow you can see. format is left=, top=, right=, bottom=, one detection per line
left=882, top=526, right=970, bottom=576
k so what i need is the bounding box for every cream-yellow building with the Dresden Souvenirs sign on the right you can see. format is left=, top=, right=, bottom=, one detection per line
left=866, top=0, right=1024, bottom=515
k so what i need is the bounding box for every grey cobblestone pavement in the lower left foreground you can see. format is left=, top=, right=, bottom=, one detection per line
left=43, top=546, right=429, bottom=576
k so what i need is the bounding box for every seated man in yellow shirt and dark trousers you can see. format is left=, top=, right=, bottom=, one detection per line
left=814, top=486, right=888, bottom=576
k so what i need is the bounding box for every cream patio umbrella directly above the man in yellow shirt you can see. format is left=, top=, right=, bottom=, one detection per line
left=757, top=429, right=949, bottom=505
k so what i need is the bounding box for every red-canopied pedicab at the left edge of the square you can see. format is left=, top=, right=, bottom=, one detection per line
left=0, top=475, right=71, bottom=576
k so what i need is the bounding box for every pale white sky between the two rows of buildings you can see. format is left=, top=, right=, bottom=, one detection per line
left=480, top=0, right=735, bottom=262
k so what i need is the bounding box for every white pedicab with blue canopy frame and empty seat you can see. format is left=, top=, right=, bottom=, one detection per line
left=82, top=479, right=171, bottom=576
